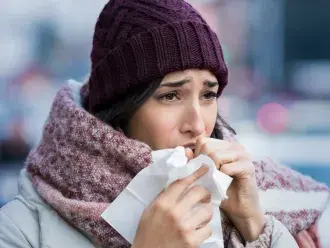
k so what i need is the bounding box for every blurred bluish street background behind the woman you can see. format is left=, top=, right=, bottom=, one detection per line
left=0, top=0, right=330, bottom=206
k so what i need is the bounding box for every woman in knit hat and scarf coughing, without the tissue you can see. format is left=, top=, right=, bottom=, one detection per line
left=0, top=0, right=328, bottom=248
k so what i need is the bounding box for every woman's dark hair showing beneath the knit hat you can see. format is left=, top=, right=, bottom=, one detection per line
left=92, top=79, right=236, bottom=139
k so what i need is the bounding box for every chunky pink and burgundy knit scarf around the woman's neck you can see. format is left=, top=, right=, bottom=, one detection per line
left=26, top=81, right=328, bottom=247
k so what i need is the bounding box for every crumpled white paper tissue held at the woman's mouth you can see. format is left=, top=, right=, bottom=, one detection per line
left=101, top=146, right=232, bottom=248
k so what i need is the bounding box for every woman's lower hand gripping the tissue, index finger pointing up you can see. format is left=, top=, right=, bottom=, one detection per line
left=132, top=166, right=213, bottom=248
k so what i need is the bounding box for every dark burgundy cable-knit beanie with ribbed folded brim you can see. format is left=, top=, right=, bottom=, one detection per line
left=88, top=0, right=228, bottom=113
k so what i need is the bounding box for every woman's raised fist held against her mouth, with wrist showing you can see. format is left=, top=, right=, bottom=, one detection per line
left=194, top=137, right=265, bottom=241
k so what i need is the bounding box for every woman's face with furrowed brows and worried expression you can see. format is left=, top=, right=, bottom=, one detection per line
left=128, top=69, right=219, bottom=150
